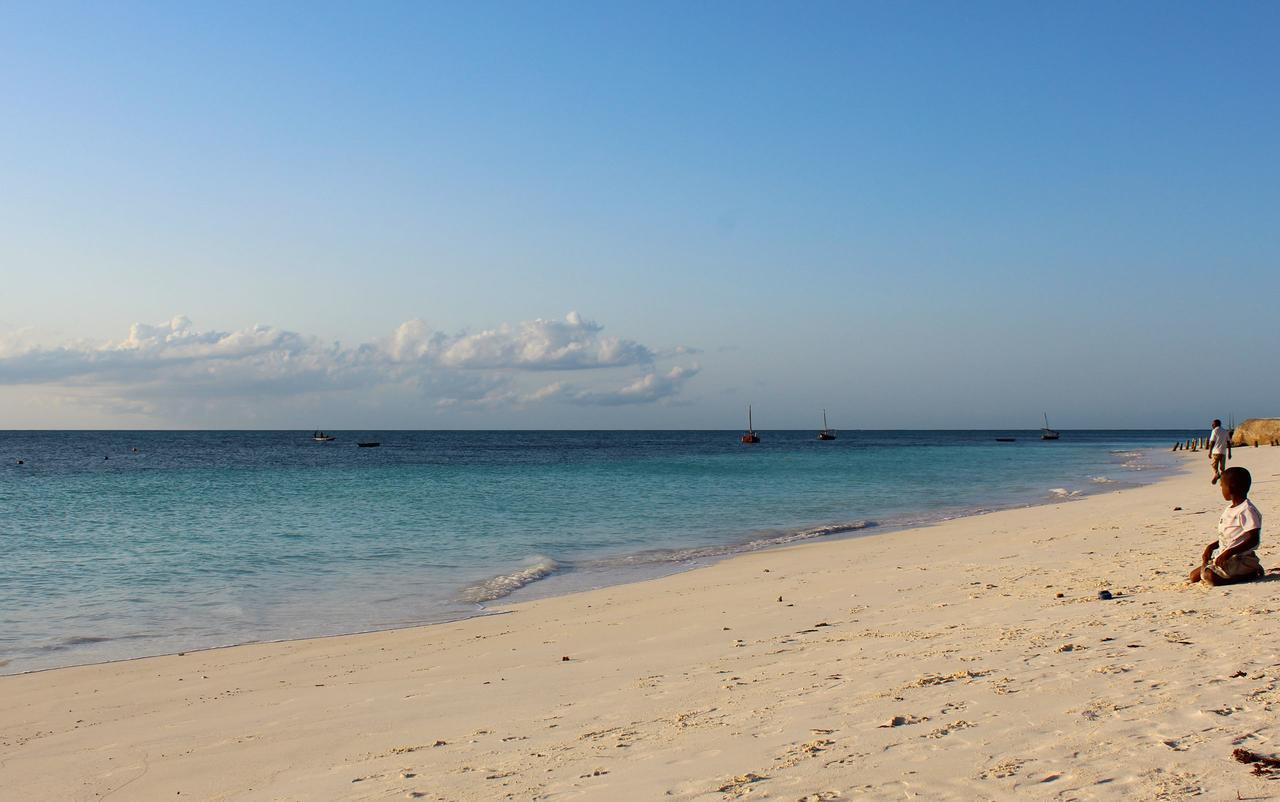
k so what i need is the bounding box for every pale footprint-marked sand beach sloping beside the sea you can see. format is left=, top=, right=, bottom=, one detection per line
left=0, top=448, right=1280, bottom=801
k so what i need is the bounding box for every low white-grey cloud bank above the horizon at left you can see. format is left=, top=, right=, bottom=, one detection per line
left=0, top=312, right=699, bottom=422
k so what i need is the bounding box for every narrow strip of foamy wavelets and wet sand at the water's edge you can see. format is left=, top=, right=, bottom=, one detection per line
left=0, top=446, right=1180, bottom=678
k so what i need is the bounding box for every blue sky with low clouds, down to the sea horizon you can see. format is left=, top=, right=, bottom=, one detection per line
left=0, top=0, right=1280, bottom=430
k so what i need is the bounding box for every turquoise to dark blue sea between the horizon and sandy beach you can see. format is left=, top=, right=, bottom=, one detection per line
left=0, top=431, right=1201, bottom=673
